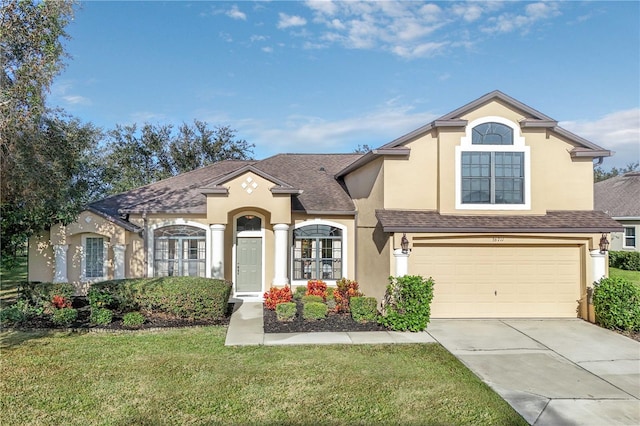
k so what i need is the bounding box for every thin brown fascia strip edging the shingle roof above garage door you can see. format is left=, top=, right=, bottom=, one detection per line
left=382, top=226, right=622, bottom=234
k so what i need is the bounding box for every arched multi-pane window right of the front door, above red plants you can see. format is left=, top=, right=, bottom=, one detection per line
left=293, top=225, right=342, bottom=280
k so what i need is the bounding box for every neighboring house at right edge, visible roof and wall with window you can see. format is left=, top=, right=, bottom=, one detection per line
left=594, top=171, right=640, bottom=251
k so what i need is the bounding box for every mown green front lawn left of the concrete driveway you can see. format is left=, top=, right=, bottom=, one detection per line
left=0, top=327, right=526, bottom=425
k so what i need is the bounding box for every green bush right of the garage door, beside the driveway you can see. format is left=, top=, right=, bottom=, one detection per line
left=593, top=278, right=640, bottom=331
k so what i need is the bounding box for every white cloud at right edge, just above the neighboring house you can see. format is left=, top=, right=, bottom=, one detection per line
left=559, top=108, right=640, bottom=169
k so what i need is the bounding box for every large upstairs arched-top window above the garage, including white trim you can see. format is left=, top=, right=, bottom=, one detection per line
left=456, top=117, right=531, bottom=210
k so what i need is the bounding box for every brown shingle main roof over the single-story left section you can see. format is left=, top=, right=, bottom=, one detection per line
left=88, top=154, right=361, bottom=220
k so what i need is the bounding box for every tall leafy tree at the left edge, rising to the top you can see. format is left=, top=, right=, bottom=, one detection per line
left=0, top=0, right=78, bottom=262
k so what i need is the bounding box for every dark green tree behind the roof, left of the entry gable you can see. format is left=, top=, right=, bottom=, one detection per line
left=103, top=120, right=254, bottom=194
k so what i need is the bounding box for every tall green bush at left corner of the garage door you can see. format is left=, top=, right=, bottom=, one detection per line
left=378, top=275, right=434, bottom=331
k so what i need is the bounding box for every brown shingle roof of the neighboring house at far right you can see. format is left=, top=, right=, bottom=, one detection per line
left=594, top=172, right=640, bottom=218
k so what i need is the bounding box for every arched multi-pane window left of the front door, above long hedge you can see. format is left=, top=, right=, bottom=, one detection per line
left=153, top=225, right=207, bottom=277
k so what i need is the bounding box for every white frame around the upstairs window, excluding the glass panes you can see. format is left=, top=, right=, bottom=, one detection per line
left=455, top=116, right=531, bottom=210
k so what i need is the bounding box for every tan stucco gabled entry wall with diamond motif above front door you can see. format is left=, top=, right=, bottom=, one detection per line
left=207, top=172, right=291, bottom=224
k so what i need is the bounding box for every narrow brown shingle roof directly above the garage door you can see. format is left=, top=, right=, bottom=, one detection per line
left=376, top=209, right=622, bottom=233
